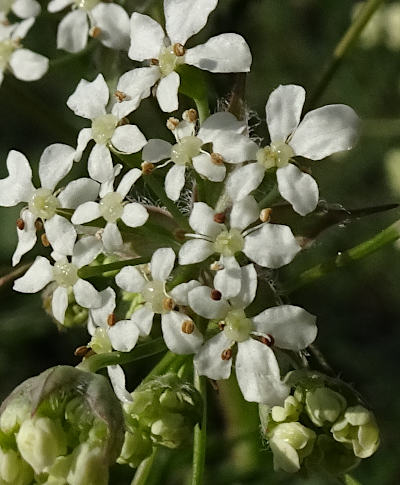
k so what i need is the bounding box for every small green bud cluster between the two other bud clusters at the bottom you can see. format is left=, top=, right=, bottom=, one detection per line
left=118, top=373, right=202, bottom=468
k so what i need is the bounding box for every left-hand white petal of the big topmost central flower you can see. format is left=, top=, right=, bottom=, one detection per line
left=128, top=12, right=165, bottom=61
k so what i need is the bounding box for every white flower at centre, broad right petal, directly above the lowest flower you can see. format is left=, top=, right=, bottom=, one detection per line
left=179, top=196, right=300, bottom=297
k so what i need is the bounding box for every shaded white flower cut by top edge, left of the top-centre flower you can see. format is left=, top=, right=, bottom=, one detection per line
left=48, top=0, right=129, bottom=52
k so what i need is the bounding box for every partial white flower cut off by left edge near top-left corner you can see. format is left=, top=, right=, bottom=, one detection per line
left=0, top=18, right=49, bottom=84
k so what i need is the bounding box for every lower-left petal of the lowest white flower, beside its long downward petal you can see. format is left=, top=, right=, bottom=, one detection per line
left=193, top=332, right=232, bottom=380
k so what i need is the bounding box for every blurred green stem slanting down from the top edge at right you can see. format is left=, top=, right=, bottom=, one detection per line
left=307, top=0, right=385, bottom=108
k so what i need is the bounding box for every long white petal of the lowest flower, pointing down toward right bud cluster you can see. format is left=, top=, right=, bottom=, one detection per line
left=236, top=339, right=289, bottom=406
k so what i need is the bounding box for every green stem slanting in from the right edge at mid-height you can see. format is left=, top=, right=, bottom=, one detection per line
left=281, top=220, right=400, bottom=294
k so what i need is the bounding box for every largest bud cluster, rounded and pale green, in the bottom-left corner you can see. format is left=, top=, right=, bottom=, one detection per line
left=0, top=366, right=123, bottom=485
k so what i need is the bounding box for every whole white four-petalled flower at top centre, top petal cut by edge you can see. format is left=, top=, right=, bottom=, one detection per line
left=128, top=0, right=251, bottom=112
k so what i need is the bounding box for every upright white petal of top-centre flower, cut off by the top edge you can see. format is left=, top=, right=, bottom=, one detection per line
left=164, top=0, right=218, bottom=45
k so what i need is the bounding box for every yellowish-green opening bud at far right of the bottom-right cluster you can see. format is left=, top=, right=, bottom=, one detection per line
left=331, top=405, right=379, bottom=458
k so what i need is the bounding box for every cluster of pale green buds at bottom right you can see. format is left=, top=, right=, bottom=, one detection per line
left=260, top=370, right=379, bottom=475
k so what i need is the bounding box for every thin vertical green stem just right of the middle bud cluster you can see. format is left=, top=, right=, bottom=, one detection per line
left=191, top=371, right=207, bottom=485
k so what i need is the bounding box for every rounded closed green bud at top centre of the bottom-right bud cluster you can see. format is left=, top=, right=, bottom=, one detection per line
left=306, top=387, right=347, bottom=427
